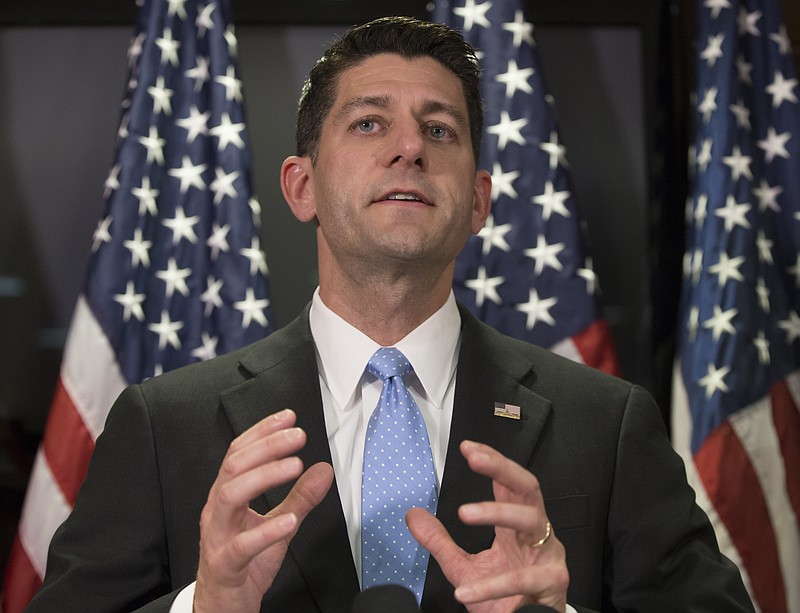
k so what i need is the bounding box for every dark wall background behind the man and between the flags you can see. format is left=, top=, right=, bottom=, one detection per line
left=0, top=0, right=800, bottom=577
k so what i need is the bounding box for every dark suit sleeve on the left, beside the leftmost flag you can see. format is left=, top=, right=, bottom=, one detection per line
left=27, top=386, right=182, bottom=613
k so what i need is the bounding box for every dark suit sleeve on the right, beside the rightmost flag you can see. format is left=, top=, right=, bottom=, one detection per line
left=604, top=387, right=753, bottom=613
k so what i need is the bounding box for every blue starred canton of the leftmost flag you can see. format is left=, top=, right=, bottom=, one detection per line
left=85, top=0, right=272, bottom=382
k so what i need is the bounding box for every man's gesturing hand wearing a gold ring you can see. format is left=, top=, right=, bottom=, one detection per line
left=406, top=441, right=569, bottom=613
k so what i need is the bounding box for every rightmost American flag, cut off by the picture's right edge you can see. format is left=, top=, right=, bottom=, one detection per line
left=672, top=0, right=800, bottom=613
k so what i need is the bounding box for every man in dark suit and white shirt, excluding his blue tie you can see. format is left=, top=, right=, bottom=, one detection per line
left=30, top=18, right=752, bottom=613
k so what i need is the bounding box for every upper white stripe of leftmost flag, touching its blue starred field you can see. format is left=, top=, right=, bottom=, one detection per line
left=61, top=294, right=127, bottom=440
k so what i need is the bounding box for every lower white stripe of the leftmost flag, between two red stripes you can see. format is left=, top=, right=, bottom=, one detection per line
left=19, top=446, right=71, bottom=579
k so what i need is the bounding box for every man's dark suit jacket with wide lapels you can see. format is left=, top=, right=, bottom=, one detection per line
left=29, top=309, right=752, bottom=613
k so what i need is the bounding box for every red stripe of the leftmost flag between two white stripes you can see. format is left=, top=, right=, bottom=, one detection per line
left=43, top=379, right=94, bottom=506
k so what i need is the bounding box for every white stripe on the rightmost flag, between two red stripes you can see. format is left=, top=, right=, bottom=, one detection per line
left=730, top=396, right=800, bottom=613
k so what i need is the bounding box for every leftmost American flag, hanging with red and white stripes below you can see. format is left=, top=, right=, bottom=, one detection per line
left=3, top=0, right=272, bottom=613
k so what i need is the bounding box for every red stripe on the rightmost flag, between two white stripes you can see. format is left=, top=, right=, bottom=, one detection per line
left=694, top=422, right=787, bottom=613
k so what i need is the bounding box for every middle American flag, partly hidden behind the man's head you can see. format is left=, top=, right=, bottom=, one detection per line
left=431, top=0, right=618, bottom=374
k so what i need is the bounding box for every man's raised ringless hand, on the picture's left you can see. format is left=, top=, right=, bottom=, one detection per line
left=194, top=409, right=333, bottom=613
